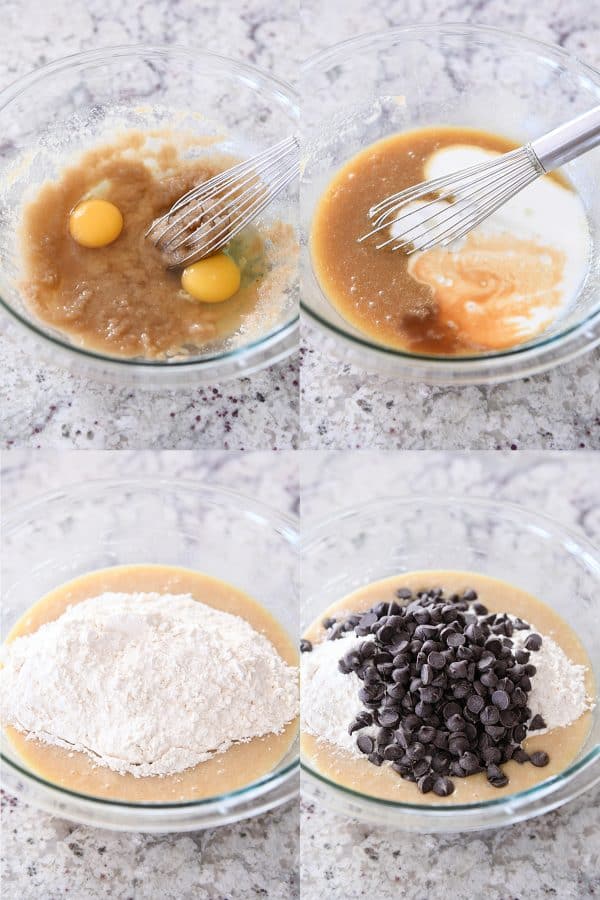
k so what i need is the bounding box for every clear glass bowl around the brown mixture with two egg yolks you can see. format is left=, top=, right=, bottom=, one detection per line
left=0, top=47, right=298, bottom=387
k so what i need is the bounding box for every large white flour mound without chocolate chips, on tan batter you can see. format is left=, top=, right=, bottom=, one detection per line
left=0, top=593, right=298, bottom=776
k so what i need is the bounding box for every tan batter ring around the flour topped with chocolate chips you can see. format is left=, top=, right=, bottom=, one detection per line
left=301, top=571, right=595, bottom=806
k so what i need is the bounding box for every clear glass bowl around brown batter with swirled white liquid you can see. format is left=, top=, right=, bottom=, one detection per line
left=300, top=25, right=600, bottom=384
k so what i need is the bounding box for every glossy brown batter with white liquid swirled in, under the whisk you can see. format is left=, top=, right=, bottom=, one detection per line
left=311, top=127, right=590, bottom=356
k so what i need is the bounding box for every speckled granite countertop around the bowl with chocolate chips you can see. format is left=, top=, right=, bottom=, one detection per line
left=300, top=451, right=600, bottom=900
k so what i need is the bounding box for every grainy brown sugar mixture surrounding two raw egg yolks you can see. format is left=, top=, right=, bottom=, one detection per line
left=21, top=132, right=297, bottom=359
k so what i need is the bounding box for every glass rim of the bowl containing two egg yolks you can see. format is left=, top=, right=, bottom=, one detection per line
left=0, top=44, right=300, bottom=374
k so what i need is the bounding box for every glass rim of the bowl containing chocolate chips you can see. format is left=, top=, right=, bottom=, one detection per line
left=300, top=494, right=600, bottom=819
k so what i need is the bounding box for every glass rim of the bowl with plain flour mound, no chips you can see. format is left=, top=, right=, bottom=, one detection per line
left=0, top=477, right=299, bottom=812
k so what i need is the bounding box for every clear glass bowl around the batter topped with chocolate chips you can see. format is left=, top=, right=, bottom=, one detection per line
left=300, top=497, right=600, bottom=833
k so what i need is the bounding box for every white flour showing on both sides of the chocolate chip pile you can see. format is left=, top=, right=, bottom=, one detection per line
left=301, top=629, right=593, bottom=757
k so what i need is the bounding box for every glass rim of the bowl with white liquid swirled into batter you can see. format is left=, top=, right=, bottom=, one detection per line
left=300, top=22, right=600, bottom=381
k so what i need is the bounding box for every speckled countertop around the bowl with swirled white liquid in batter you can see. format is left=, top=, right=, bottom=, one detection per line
left=301, top=0, right=600, bottom=450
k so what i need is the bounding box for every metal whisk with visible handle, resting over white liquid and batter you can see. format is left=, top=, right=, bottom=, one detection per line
left=358, top=106, right=600, bottom=254
